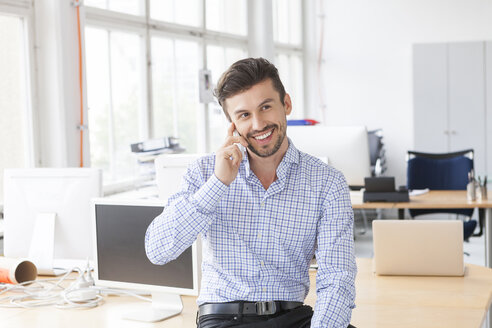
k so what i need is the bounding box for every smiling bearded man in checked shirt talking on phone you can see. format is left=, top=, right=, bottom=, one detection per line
left=145, top=58, right=357, bottom=328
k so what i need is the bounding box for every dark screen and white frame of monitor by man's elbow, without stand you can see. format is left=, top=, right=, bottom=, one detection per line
left=94, top=200, right=197, bottom=294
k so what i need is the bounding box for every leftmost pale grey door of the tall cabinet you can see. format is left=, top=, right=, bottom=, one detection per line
left=413, top=44, right=448, bottom=153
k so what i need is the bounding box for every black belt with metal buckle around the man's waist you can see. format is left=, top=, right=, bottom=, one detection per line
left=198, top=301, right=303, bottom=317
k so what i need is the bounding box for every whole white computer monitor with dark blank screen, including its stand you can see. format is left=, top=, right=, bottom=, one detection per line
left=93, top=199, right=200, bottom=322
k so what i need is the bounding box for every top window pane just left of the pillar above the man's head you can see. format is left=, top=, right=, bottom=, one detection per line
left=205, top=0, right=248, bottom=35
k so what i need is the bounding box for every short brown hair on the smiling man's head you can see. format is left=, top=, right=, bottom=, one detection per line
left=214, top=58, right=285, bottom=121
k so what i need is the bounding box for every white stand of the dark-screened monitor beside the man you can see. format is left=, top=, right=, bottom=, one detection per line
left=123, top=292, right=183, bottom=322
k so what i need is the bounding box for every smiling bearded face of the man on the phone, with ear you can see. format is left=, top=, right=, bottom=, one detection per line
left=225, top=79, right=292, bottom=157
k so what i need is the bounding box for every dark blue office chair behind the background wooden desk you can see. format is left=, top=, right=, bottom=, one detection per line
left=407, top=149, right=477, bottom=240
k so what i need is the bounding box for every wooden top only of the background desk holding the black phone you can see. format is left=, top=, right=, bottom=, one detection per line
left=351, top=190, right=492, bottom=209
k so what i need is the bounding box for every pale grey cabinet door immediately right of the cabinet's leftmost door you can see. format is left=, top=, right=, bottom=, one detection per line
left=448, top=42, right=486, bottom=174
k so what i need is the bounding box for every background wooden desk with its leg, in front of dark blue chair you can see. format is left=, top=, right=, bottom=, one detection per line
left=352, top=190, right=492, bottom=268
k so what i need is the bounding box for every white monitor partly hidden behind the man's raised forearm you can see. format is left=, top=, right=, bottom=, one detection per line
left=154, top=154, right=206, bottom=201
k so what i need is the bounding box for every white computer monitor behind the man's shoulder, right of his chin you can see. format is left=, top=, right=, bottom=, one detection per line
left=287, top=125, right=371, bottom=188
